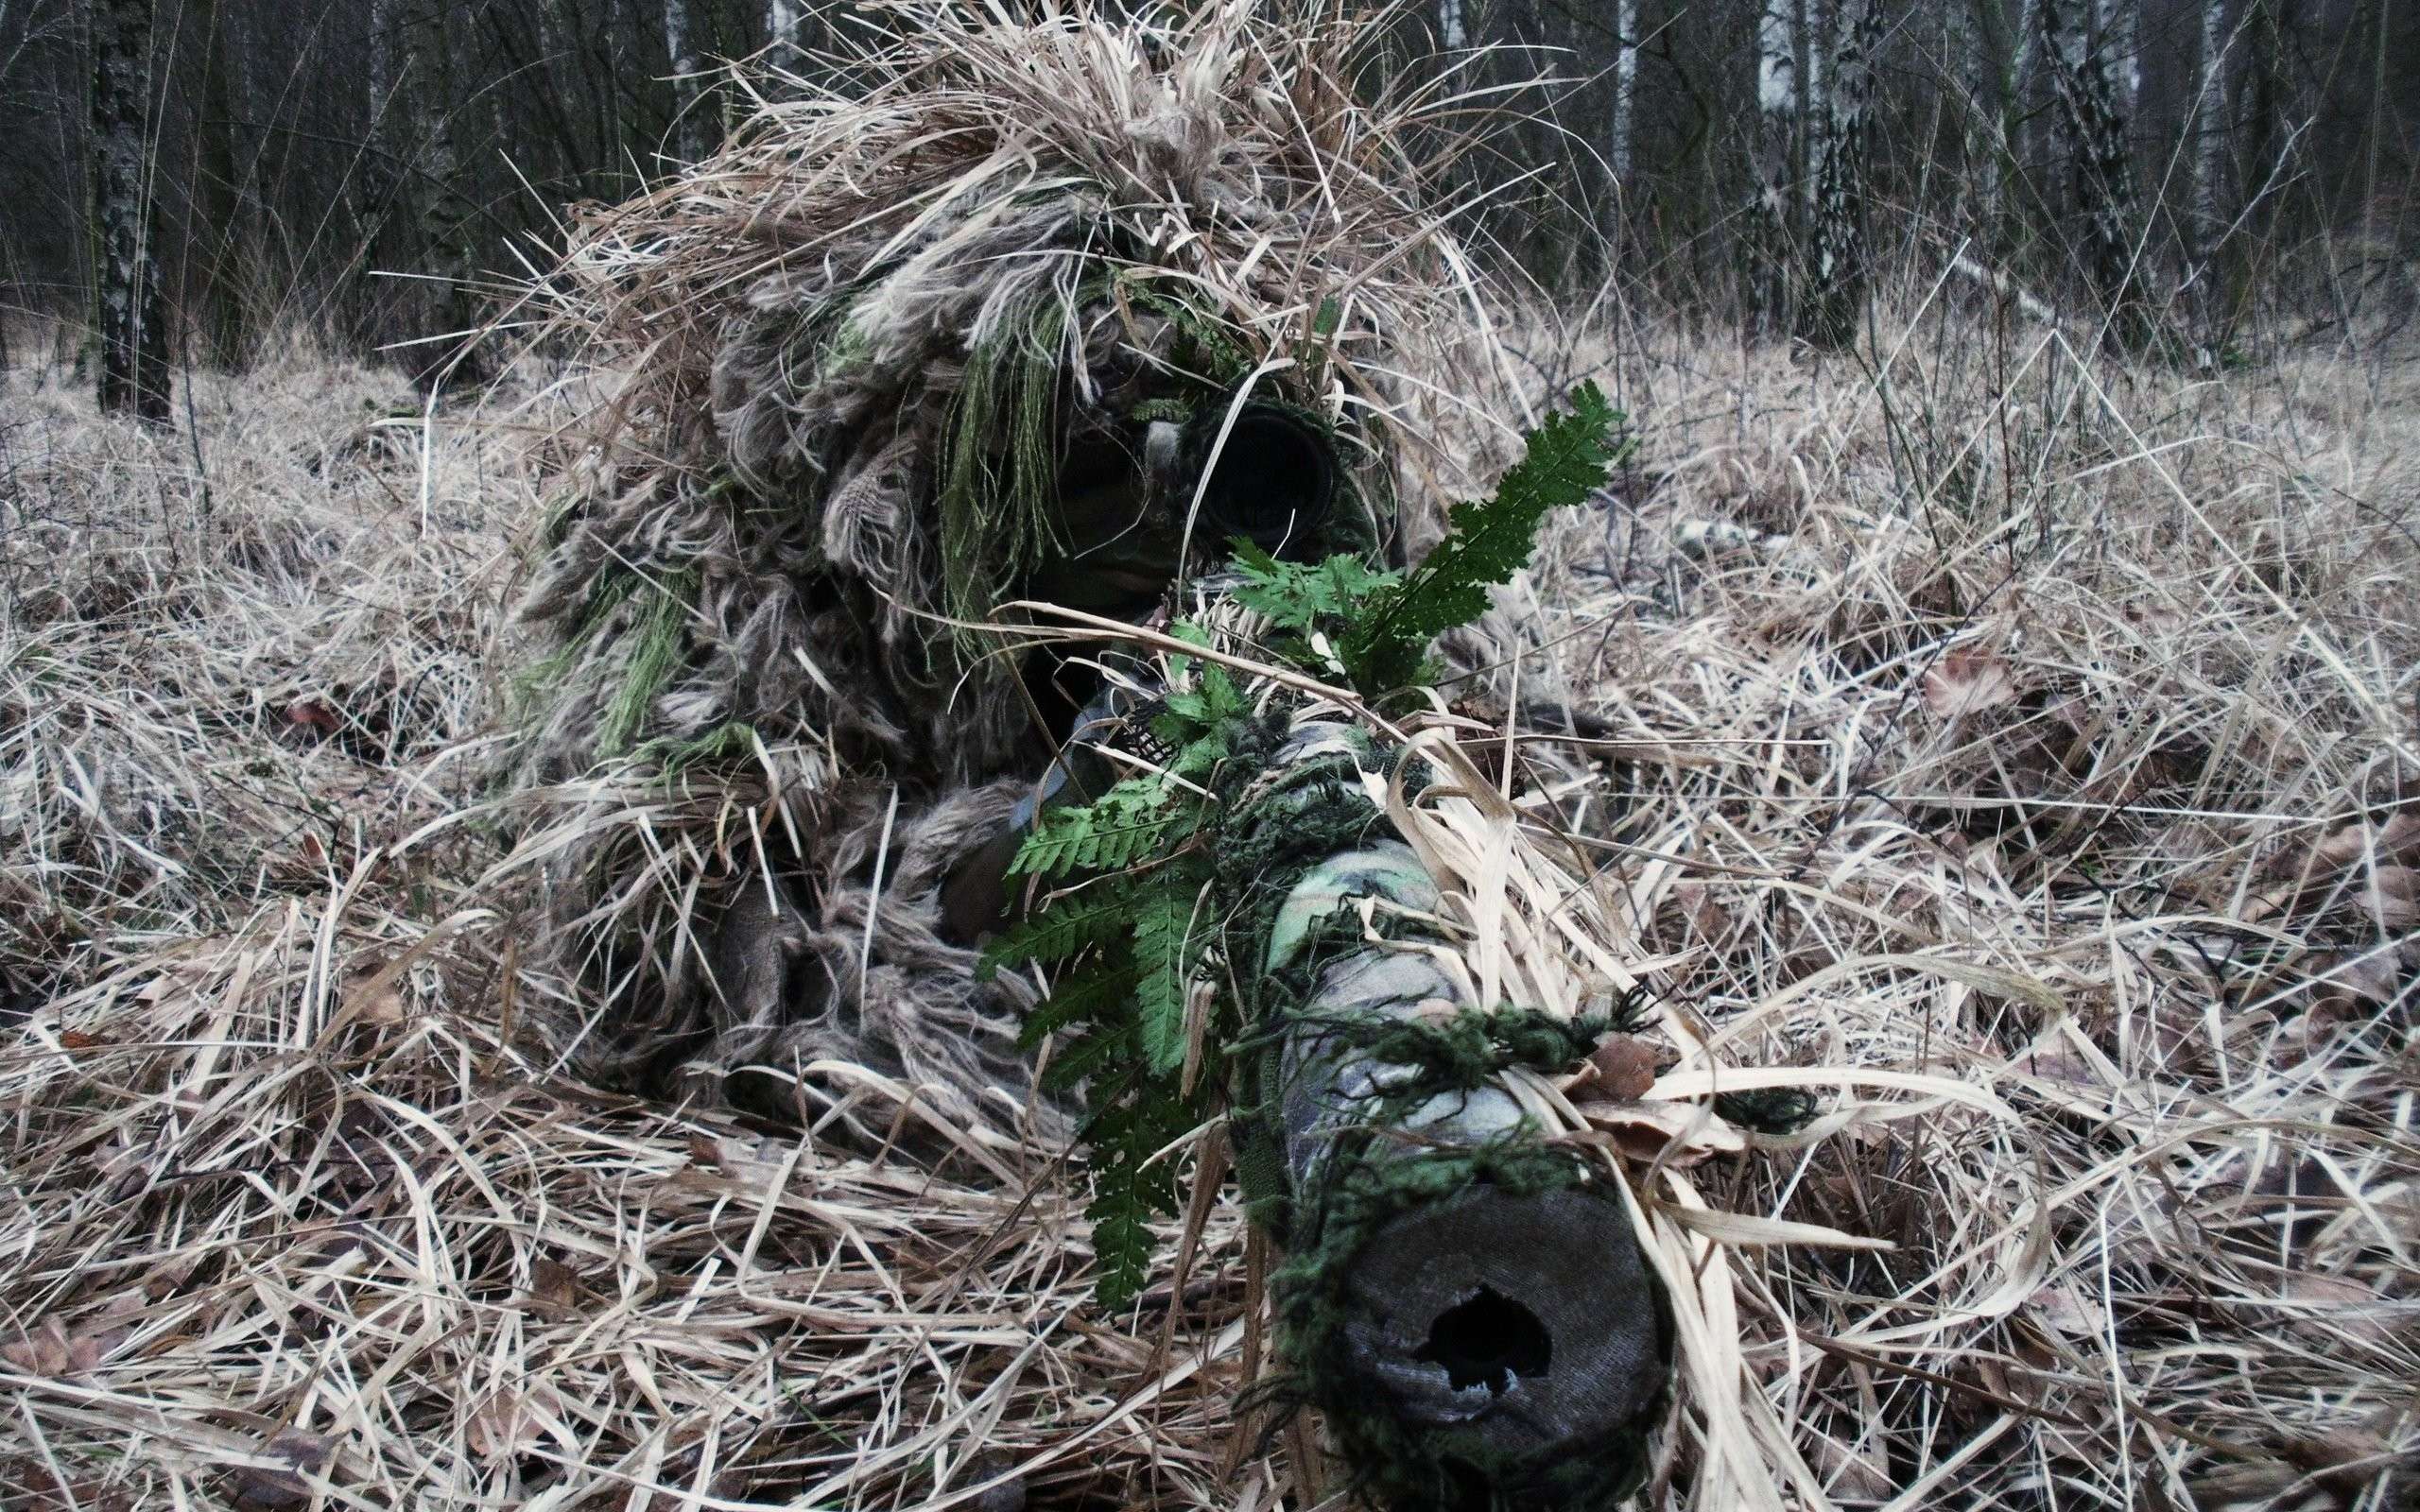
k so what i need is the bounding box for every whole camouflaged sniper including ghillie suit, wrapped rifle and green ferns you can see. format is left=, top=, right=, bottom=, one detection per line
left=495, top=5, right=1761, bottom=1507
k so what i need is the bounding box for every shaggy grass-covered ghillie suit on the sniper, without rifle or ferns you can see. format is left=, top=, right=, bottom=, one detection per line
left=500, top=5, right=1500, bottom=1113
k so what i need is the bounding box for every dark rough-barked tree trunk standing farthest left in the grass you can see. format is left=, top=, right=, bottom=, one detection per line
left=92, top=0, right=169, bottom=426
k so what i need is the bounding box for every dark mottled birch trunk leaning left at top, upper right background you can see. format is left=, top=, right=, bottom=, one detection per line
left=2043, top=0, right=2152, bottom=351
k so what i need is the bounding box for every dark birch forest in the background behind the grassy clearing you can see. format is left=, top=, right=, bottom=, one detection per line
left=0, top=0, right=2420, bottom=399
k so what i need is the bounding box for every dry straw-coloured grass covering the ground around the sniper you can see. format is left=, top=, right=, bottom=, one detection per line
left=0, top=310, right=2420, bottom=1512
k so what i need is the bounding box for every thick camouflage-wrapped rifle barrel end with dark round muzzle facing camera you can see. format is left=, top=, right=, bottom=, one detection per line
left=1275, top=839, right=1669, bottom=1509
